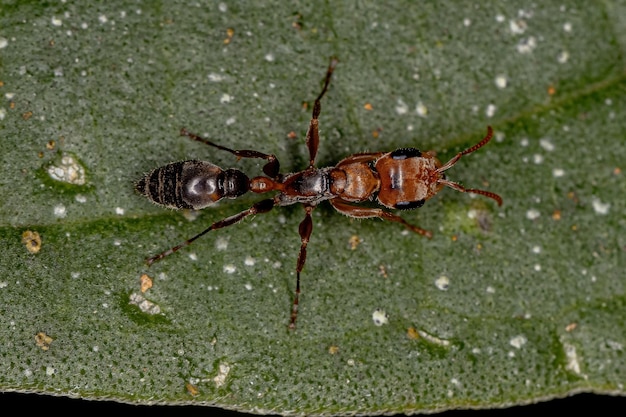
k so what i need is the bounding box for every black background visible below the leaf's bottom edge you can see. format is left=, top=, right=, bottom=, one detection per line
left=0, top=393, right=626, bottom=417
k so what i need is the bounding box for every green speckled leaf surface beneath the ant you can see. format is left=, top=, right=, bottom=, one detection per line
left=0, top=1, right=626, bottom=414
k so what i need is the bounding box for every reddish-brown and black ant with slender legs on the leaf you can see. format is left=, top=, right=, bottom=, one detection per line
left=135, top=59, right=502, bottom=329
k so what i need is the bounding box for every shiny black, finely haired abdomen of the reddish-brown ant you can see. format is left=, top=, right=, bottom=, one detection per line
left=135, top=161, right=250, bottom=210
